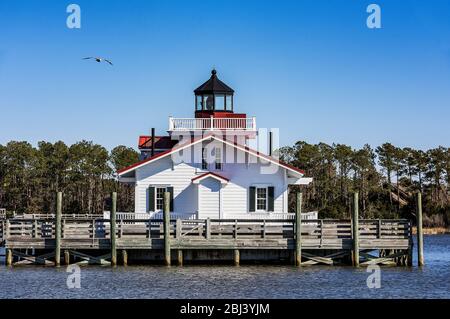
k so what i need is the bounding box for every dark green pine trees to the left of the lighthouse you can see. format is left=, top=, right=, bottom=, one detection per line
left=0, top=141, right=139, bottom=214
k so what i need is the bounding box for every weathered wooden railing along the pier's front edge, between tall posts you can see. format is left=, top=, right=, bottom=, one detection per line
left=0, top=217, right=411, bottom=248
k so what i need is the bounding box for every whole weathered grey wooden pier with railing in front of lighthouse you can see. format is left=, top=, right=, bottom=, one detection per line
left=0, top=192, right=413, bottom=266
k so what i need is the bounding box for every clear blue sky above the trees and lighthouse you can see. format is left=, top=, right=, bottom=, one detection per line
left=0, top=0, right=450, bottom=149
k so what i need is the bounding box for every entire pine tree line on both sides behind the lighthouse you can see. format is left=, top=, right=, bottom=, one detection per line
left=0, top=141, right=450, bottom=226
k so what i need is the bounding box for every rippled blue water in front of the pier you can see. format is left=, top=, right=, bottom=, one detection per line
left=0, top=235, right=450, bottom=298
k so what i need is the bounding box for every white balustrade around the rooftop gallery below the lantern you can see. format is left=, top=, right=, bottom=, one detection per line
left=169, top=117, right=256, bottom=131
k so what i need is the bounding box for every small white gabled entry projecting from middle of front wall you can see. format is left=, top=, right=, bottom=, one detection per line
left=198, top=178, right=221, bottom=219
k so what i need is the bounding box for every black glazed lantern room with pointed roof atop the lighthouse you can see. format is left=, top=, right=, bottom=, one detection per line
left=194, top=69, right=234, bottom=113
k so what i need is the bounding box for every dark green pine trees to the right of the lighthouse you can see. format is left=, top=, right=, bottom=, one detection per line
left=279, top=141, right=450, bottom=227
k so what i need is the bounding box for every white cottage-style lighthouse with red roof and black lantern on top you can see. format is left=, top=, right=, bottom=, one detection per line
left=118, top=70, right=312, bottom=219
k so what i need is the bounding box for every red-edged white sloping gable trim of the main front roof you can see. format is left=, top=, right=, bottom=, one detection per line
left=117, top=133, right=305, bottom=175
